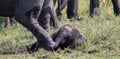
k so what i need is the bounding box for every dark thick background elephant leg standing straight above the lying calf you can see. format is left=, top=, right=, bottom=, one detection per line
left=67, top=0, right=82, bottom=20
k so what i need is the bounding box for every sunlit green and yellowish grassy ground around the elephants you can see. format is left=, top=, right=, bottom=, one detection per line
left=0, top=0, right=120, bottom=59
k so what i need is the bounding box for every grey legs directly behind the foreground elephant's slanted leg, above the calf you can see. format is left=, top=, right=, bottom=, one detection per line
left=38, top=0, right=60, bottom=31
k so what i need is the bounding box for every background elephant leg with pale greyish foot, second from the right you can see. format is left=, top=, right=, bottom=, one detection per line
left=90, top=0, right=100, bottom=17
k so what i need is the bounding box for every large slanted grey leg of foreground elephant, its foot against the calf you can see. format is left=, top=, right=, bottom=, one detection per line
left=14, top=0, right=55, bottom=51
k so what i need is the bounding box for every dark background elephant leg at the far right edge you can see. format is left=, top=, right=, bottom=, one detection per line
left=111, top=0, right=120, bottom=16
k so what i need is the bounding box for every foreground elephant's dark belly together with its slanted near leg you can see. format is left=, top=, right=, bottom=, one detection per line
left=0, top=0, right=55, bottom=51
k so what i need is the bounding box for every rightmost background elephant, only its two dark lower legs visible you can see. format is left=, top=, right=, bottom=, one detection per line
left=90, top=0, right=120, bottom=17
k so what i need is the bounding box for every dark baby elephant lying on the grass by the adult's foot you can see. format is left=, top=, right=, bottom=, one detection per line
left=20, top=24, right=87, bottom=52
